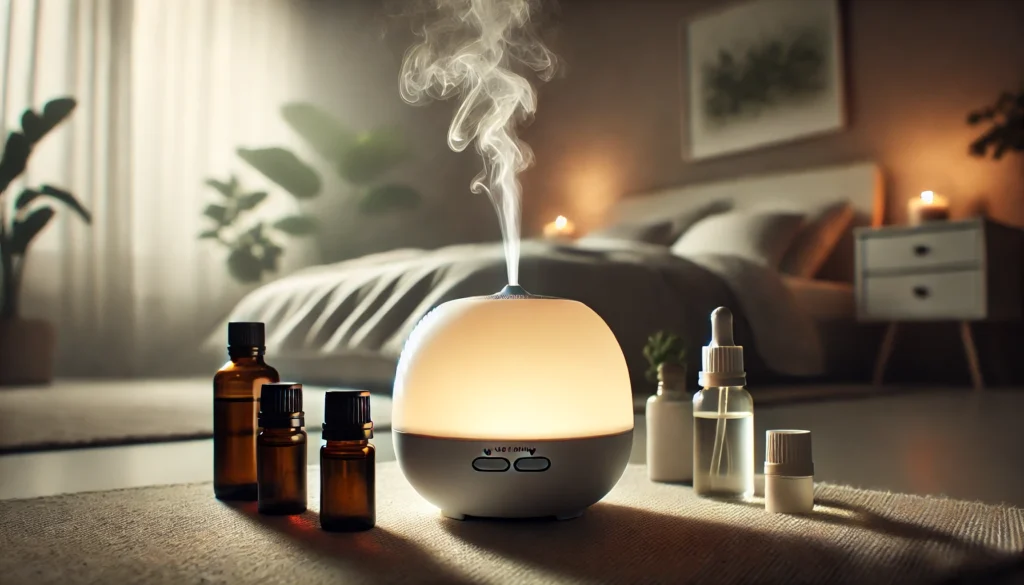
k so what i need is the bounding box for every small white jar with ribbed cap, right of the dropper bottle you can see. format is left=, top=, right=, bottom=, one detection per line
left=765, top=430, right=814, bottom=514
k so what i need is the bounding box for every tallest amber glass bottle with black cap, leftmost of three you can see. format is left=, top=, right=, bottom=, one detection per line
left=213, top=323, right=281, bottom=501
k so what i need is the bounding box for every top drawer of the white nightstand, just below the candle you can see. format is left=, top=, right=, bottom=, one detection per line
left=860, top=227, right=982, bottom=273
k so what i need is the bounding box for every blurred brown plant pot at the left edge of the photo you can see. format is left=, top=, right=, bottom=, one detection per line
left=0, top=318, right=56, bottom=386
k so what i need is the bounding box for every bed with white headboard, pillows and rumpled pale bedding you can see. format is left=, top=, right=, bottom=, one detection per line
left=207, top=163, right=884, bottom=392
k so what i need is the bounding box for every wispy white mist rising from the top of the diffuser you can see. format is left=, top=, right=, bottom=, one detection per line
left=399, top=0, right=556, bottom=285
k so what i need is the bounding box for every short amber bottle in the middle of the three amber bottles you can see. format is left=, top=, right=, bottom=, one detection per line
left=256, top=382, right=306, bottom=514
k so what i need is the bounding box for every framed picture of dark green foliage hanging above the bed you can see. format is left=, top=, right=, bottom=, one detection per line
left=680, top=0, right=847, bottom=160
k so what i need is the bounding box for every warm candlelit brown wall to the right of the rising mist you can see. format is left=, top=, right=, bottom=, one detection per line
left=523, top=0, right=1024, bottom=229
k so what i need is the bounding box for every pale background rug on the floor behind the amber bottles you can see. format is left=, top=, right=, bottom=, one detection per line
left=0, top=378, right=391, bottom=454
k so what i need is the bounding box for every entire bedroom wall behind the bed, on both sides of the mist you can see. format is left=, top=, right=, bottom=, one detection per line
left=304, top=0, right=1024, bottom=260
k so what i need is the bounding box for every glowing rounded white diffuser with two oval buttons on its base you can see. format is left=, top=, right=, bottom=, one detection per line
left=392, top=286, right=633, bottom=519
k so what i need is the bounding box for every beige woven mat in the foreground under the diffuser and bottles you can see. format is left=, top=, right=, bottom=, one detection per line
left=0, top=462, right=1024, bottom=585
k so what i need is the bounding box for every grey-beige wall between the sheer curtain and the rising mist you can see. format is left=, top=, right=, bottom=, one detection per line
left=297, top=0, right=501, bottom=261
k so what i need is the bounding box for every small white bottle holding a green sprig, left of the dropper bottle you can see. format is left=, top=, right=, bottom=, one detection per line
left=646, top=364, right=693, bottom=482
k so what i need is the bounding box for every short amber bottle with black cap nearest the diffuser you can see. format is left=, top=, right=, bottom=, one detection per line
left=321, top=391, right=377, bottom=532
